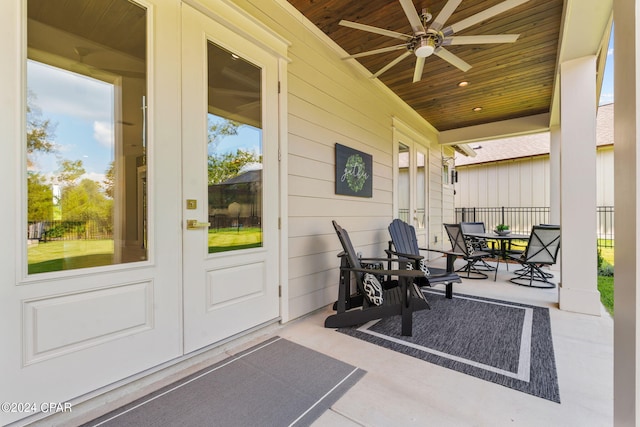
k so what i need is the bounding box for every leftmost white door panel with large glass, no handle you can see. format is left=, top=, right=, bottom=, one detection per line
left=0, top=0, right=183, bottom=425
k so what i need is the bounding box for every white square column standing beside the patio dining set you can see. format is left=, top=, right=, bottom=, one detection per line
left=559, top=56, right=601, bottom=316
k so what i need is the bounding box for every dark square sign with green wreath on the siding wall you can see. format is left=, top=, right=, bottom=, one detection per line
left=336, top=144, right=373, bottom=197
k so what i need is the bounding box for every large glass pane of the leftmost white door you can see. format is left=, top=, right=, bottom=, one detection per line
left=25, top=0, right=147, bottom=274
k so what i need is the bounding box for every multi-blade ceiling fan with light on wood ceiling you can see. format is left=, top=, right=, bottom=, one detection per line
left=339, top=0, right=529, bottom=83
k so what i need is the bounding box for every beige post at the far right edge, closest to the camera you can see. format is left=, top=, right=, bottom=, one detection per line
left=613, top=0, right=640, bottom=427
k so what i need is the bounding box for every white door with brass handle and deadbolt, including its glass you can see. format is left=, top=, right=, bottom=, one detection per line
left=182, top=4, right=280, bottom=353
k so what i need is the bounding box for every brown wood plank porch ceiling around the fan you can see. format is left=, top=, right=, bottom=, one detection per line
left=288, top=0, right=563, bottom=131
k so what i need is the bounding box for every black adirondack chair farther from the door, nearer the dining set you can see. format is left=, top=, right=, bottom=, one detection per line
left=387, top=219, right=462, bottom=299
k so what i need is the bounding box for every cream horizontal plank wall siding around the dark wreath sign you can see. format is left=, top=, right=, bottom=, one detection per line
left=237, top=0, right=453, bottom=319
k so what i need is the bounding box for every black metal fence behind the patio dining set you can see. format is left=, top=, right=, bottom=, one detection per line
left=456, top=206, right=615, bottom=248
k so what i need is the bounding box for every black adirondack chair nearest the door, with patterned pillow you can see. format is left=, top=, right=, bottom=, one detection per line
left=324, top=221, right=430, bottom=336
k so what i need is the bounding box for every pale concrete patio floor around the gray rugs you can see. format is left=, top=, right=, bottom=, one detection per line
left=28, top=258, right=613, bottom=427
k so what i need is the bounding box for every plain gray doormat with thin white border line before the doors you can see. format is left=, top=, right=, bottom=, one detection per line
left=85, top=337, right=365, bottom=427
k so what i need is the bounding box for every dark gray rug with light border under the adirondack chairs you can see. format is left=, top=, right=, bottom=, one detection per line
left=338, top=290, right=560, bottom=403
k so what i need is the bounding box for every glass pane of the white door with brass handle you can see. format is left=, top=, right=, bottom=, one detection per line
left=207, top=42, right=263, bottom=253
